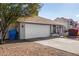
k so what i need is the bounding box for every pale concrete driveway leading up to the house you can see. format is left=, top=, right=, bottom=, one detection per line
left=35, top=38, right=79, bottom=55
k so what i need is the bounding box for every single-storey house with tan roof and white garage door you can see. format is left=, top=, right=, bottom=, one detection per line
left=17, top=16, right=64, bottom=39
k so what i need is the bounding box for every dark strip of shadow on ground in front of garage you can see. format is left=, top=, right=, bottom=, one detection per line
left=5, top=37, right=57, bottom=44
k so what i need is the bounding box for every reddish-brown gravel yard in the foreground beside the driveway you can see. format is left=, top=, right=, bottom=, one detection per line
left=0, top=42, right=76, bottom=56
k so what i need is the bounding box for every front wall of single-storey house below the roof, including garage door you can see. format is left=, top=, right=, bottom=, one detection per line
left=20, top=23, right=64, bottom=39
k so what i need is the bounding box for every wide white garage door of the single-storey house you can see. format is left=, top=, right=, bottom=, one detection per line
left=25, top=24, right=50, bottom=39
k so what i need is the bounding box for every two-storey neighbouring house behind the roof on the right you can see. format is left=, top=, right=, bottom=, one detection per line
left=54, top=17, right=77, bottom=30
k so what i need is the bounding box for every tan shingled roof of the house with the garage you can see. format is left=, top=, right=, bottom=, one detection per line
left=17, top=16, right=62, bottom=25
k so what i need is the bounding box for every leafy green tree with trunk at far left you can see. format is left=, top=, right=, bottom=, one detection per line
left=0, top=3, right=41, bottom=43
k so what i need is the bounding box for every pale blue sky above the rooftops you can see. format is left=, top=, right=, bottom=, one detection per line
left=39, top=3, right=79, bottom=21
